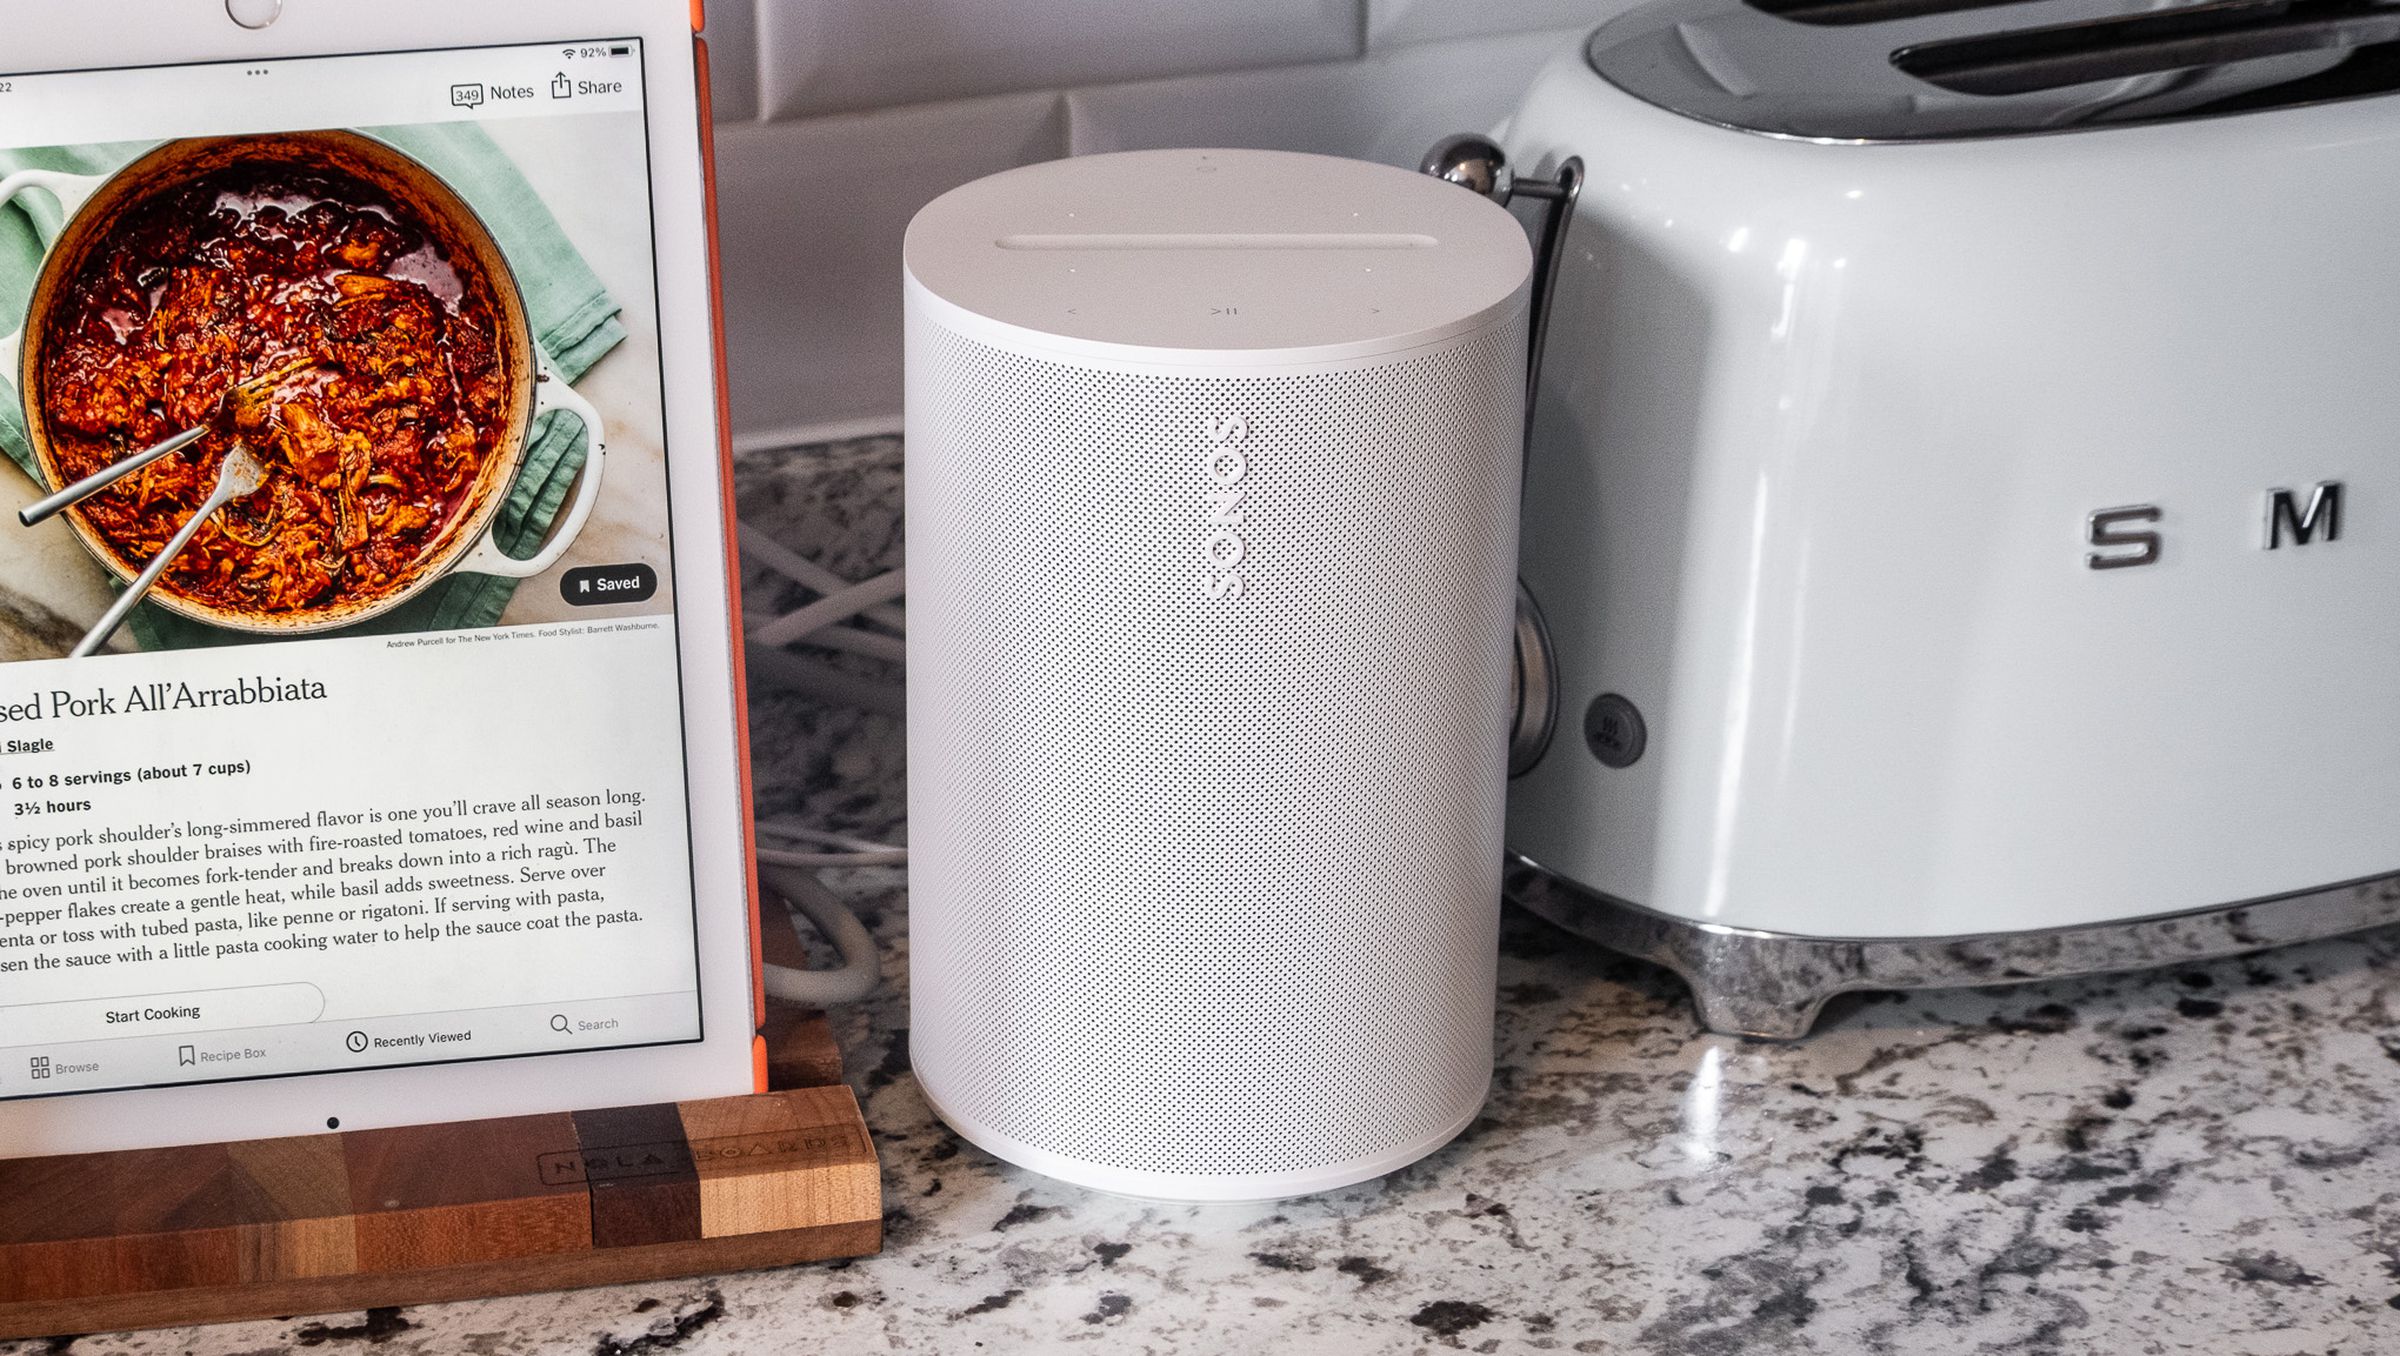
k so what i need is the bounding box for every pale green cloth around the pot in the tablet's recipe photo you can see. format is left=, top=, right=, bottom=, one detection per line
left=0, top=122, right=624, bottom=650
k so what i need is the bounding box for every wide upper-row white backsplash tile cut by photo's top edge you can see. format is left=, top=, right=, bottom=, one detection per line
left=758, top=0, right=1361, bottom=118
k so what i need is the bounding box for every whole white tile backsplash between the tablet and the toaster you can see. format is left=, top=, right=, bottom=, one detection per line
left=708, top=0, right=1632, bottom=446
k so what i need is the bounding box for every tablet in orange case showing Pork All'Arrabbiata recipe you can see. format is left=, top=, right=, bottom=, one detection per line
left=0, top=0, right=763, bottom=1157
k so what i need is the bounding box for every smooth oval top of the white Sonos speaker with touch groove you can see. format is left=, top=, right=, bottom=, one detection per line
left=902, top=149, right=1534, bottom=367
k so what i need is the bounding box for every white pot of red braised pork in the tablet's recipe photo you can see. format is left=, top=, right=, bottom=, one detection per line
left=0, top=132, right=605, bottom=634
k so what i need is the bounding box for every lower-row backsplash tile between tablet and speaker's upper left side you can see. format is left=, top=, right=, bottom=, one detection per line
left=718, top=92, right=1066, bottom=444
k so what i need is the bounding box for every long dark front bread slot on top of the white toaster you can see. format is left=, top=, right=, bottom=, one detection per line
left=1891, top=0, right=2400, bottom=103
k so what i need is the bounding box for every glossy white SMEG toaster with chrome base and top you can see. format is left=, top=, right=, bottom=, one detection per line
left=1428, top=0, right=2400, bottom=1037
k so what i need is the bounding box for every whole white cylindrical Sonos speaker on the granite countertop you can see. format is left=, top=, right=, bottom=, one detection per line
left=905, top=151, right=1531, bottom=1200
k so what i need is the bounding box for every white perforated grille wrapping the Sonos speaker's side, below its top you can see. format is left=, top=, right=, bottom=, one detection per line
left=907, top=314, right=1522, bottom=1176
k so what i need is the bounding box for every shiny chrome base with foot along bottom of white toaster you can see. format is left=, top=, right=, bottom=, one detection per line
left=1507, top=854, right=2400, bottom=1039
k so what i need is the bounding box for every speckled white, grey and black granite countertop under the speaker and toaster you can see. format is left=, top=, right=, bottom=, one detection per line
left=18, top=442, right=2400, bottom=1356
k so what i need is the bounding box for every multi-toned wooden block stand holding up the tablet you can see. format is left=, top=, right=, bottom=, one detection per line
left=0, top=926, right=883, bottom=1339
